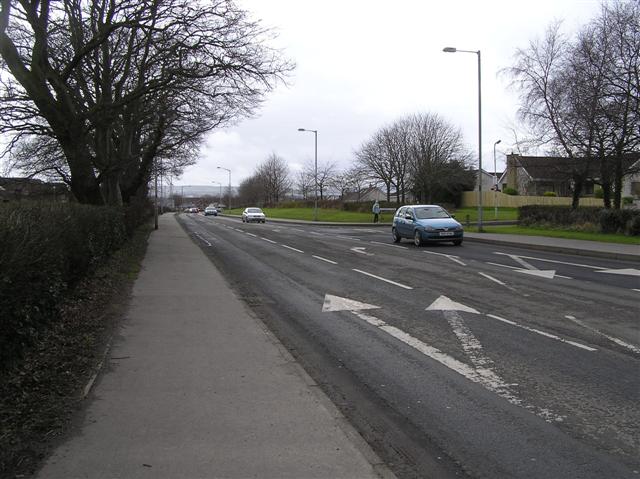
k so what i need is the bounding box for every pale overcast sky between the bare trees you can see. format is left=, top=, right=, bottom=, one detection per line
left=180, top=0, right=600, bottom=185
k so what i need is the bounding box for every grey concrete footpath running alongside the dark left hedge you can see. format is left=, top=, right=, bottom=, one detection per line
left=37, top=215, right=394, bottom=479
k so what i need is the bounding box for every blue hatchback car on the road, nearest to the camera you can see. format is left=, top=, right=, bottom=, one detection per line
left=391, top=205, right=464, bottom=246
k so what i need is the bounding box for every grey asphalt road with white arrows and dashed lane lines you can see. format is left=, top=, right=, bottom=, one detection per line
left=180, top=215, right=640, bottom=478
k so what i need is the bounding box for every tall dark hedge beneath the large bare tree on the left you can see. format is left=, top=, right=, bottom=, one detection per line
left=0, top=202, right=151, bottom=367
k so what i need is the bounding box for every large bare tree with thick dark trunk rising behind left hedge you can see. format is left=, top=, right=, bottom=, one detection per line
left=0, top=0, right=292, bottom=204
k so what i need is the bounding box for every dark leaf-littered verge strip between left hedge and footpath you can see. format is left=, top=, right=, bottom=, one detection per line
left=0, top=227, right=151, bottom=479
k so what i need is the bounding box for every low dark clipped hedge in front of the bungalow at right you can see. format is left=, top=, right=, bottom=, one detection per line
left=518, top=205, right=640, bottom=236
